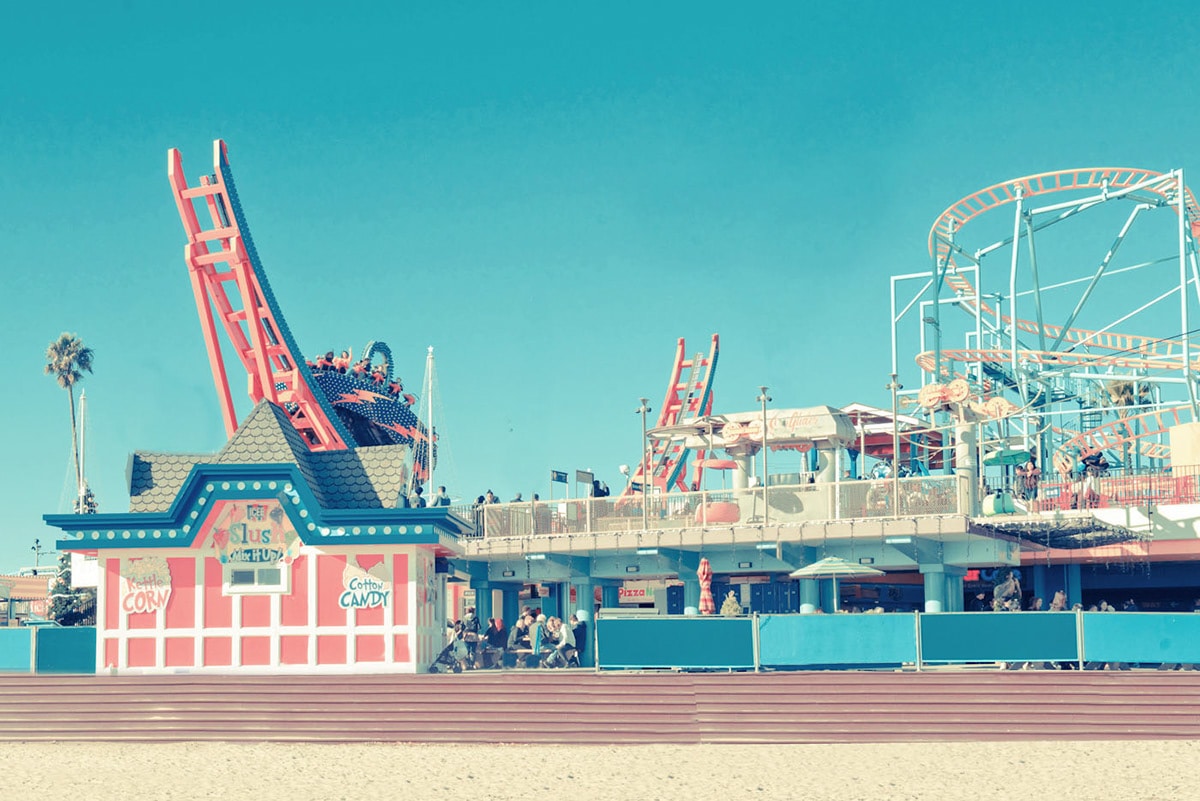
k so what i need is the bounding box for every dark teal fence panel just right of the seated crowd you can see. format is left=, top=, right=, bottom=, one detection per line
left=596, top=616, right=755, bottom=670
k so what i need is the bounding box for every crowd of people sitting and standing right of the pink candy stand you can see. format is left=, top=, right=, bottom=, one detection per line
left=441, top=606, right=588, bottom=670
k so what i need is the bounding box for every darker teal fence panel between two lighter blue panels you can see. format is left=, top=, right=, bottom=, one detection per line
left=920, top=612, right=1079, bottom=662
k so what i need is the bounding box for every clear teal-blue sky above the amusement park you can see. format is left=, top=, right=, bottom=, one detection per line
left=7, top=2, right=1200, bottom=572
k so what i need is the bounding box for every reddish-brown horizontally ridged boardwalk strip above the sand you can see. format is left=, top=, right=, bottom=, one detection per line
left=0, top=670, right=1200, bottom=745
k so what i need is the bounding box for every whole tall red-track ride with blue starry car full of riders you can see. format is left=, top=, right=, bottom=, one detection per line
left=167, top=139, right=437, bottom=496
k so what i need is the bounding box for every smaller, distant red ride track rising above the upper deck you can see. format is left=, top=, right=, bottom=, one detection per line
left=620, top=333, right=720, bottom=499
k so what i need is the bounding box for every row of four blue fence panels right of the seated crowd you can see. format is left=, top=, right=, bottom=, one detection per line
left=595, top=612, right=1200, bottom=670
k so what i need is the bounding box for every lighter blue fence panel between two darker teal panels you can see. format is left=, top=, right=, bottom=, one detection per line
left=758, top=614, right=917, bottom=668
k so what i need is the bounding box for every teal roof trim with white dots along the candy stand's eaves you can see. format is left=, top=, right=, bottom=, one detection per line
left=42, top=464, right=470, bottom=550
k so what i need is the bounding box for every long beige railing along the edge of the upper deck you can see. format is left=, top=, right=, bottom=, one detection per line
left=454, top=476, right=959, bottom=537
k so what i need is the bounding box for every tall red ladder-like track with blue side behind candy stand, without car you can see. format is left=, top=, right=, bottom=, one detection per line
left=167, top=139, right=354, bottom=451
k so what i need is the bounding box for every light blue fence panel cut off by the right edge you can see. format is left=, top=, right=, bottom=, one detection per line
left=1084, top=612, right=1200, bottom=663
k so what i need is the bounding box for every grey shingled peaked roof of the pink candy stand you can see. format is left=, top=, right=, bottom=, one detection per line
left=130, top=401, right=408, bottom=512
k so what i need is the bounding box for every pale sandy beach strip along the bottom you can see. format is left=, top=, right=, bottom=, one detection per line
left=0, top=741, right=1200, bottom=801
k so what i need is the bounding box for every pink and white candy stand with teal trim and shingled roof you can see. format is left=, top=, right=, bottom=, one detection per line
left=46, top=401, right=466, bottom=674
